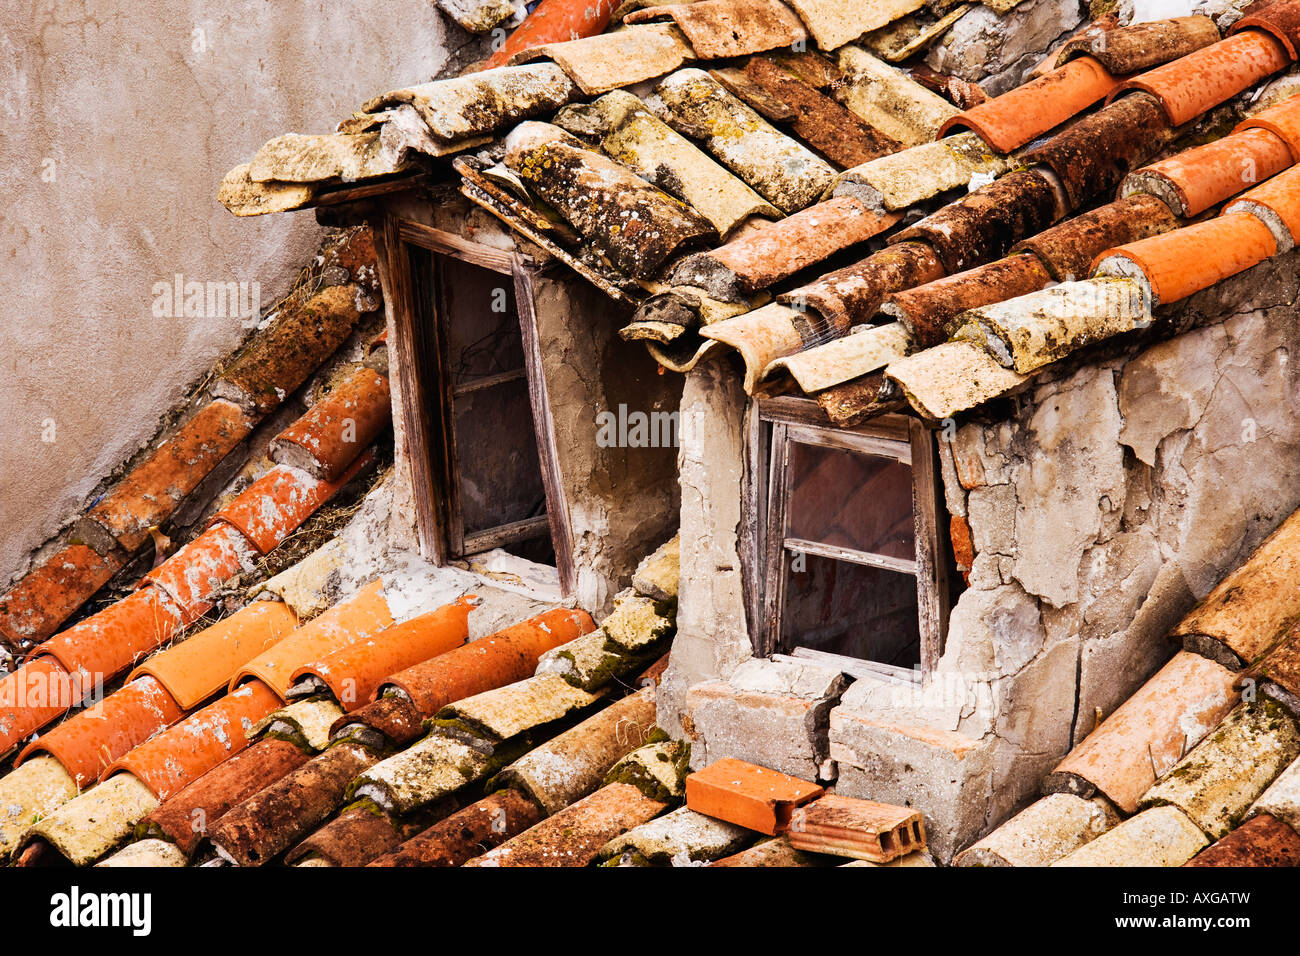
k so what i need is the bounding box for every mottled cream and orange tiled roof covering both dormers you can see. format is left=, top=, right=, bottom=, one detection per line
left=221, top=0, right=1300, bottom=434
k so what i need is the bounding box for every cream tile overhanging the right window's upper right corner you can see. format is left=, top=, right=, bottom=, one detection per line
left=885, top=342, right=1027, bottom=421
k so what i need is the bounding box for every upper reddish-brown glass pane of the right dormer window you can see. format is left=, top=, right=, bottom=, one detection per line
left=785, top=441, right=917, bottom=561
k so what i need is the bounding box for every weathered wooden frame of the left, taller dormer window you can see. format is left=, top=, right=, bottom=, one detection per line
left=384, top=215, right=577, bottom=597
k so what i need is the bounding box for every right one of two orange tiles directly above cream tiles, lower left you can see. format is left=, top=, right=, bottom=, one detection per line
left=104, top=682, right=280, bottom=816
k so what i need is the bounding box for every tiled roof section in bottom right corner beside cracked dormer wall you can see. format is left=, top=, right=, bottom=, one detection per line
left=956, top=512, right=1300, bottom=866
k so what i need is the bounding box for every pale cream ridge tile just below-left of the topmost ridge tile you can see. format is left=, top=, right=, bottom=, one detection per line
left=511, top=23, right=694, bottom=96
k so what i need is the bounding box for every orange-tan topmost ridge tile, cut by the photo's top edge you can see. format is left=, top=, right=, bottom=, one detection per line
left=623, top=0, right=807, bottom=60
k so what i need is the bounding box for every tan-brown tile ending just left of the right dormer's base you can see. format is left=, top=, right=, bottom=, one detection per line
left=489, top=687, right=655, bottom=814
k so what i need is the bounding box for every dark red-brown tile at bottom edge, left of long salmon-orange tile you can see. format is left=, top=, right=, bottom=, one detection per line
left=367, top=790, right=542, bottom=866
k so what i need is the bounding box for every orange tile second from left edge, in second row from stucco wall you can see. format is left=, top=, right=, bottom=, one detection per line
left=29, top=587, right=183, bottom=682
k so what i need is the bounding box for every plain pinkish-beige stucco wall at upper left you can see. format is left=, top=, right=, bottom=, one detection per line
left=0, top=0, right=463, bottom=583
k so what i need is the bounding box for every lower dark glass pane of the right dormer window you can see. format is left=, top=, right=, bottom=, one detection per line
left=781, top=551, right=920, bottom=667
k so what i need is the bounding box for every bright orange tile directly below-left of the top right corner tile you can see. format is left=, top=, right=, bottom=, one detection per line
left=1112, top=29, right=1291, bottom=126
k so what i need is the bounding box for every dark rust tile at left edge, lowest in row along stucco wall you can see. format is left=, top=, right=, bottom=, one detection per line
left=0, top=544, right=124, bottom=649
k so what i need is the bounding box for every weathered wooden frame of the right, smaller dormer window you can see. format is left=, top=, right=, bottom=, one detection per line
left=741, top=395, right=949, bottom=679
